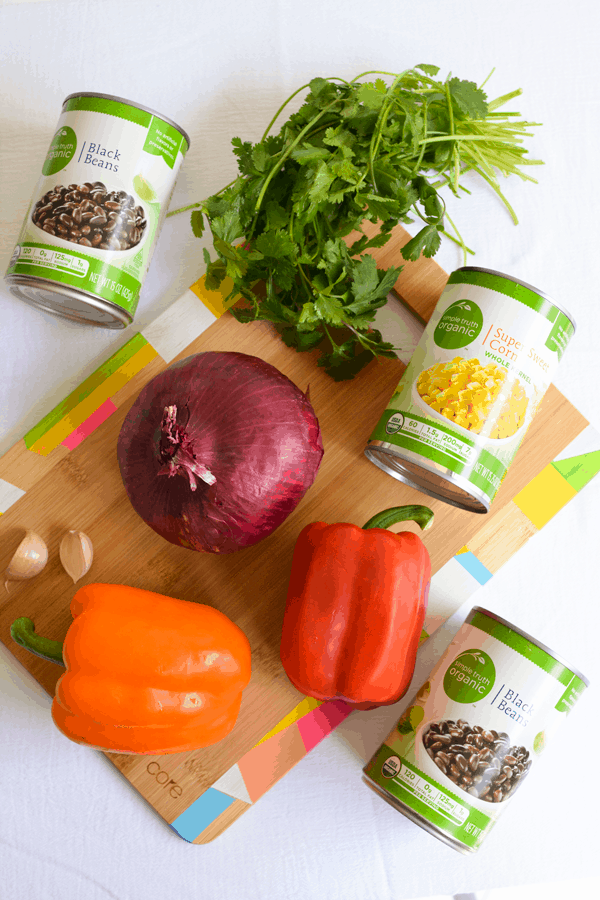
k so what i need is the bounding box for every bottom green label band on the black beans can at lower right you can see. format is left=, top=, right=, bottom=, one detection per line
left=365, top=744, right=494, bottom=849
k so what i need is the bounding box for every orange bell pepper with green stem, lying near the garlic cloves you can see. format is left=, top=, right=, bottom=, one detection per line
left=11, top=584, right=250, bottom=754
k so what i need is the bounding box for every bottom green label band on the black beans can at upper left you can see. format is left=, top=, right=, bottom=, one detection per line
left=6, top=241, right=142, bottom=314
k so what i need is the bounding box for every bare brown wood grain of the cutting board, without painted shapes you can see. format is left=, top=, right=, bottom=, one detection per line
left=0, top=228, right=587, bottom=840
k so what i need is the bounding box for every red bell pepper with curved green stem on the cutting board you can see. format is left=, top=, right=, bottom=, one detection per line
left=281, top=506, right=433, bottom=709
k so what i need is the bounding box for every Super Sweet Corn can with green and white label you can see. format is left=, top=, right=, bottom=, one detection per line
left=365, top=266, right=575, bottom=513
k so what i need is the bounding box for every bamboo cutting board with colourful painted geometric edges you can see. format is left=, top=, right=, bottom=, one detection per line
left=0, top=221, right=600, bottom=843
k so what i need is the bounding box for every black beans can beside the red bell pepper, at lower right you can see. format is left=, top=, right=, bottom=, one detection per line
left=363, top=607, right=589, bottom=853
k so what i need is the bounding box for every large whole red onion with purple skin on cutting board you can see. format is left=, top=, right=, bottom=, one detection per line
left=117, top=352, right=323, bottom=553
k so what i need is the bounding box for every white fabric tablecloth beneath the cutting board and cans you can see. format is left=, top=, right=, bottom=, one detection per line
left=0, top=0, right=600, bottom=900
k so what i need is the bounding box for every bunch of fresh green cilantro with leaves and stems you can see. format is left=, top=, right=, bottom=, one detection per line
left=180, top=65, right=539, bottom=380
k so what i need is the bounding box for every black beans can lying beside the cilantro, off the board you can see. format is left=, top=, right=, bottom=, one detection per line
left=5, top=93, right=190, bottom=328
